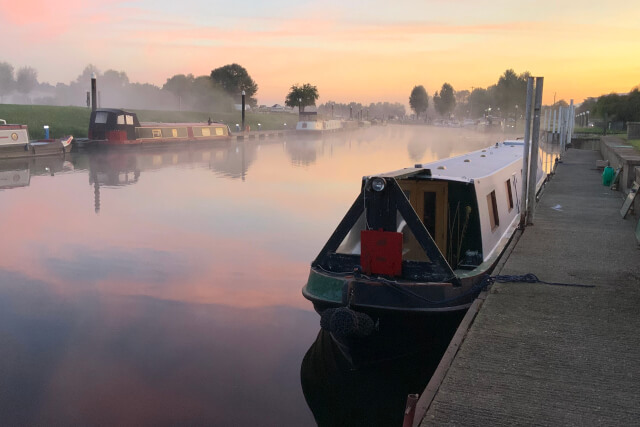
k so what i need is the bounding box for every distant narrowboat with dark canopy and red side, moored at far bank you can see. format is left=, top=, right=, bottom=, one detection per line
left=84, top=108, right=231, bottom=147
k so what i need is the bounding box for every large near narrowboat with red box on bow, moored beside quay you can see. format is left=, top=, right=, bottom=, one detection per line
left=302, top=141, right=545, bottom=362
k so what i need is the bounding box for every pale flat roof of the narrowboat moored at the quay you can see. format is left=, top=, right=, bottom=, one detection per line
left=374, top=140, right=524, bottom=182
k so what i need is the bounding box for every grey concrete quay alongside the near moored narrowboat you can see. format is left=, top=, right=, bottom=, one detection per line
left=414, top=149, right=640, bottom=426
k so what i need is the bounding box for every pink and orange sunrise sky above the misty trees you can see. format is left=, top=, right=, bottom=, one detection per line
left=0, top=0, right=640, bottom=105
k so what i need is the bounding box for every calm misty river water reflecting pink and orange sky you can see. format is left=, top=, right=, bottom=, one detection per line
left=0, top=126, right=528, bottom=426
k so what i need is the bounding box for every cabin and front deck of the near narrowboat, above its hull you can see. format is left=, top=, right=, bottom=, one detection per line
left=312, top=142, right=542, bottom=281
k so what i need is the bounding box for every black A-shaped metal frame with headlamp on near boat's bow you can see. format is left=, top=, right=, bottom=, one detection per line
left=311, top=175, right=459, bottom=285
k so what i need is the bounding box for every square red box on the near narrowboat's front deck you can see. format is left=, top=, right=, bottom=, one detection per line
left=360, top=230, right=402, bottom=276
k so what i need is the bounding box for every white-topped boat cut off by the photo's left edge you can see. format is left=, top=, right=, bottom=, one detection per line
left=0, top=119, right=73, bottom=159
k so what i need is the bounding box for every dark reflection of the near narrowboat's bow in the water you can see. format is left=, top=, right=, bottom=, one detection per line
left=300, top=330, right=448, bottom=427
